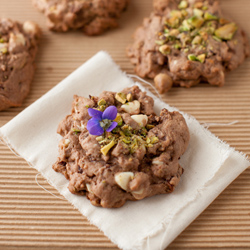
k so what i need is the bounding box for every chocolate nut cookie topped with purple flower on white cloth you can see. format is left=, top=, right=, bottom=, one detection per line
left=53, top=86, right=189, bottom=208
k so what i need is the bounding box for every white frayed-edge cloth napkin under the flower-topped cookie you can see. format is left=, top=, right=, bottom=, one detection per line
left=0, top=52, right=250, bottom=250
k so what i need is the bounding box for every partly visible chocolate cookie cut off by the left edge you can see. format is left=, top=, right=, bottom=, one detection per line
left=0, top=18, right=40, bottom=111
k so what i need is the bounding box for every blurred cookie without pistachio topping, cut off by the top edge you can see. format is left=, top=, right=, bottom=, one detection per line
left=33, top=0, right=129, bottom=36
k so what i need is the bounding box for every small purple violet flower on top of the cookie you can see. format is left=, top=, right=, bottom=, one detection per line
left=87, top=106, right=117, bottom=135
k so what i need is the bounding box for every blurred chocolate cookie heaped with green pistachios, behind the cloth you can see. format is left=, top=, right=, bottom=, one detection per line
left=127, top=0, right=249, bottom=93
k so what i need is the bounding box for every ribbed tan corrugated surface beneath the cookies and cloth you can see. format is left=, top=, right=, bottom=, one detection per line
left=0, top=0, right=250, bottom=250
